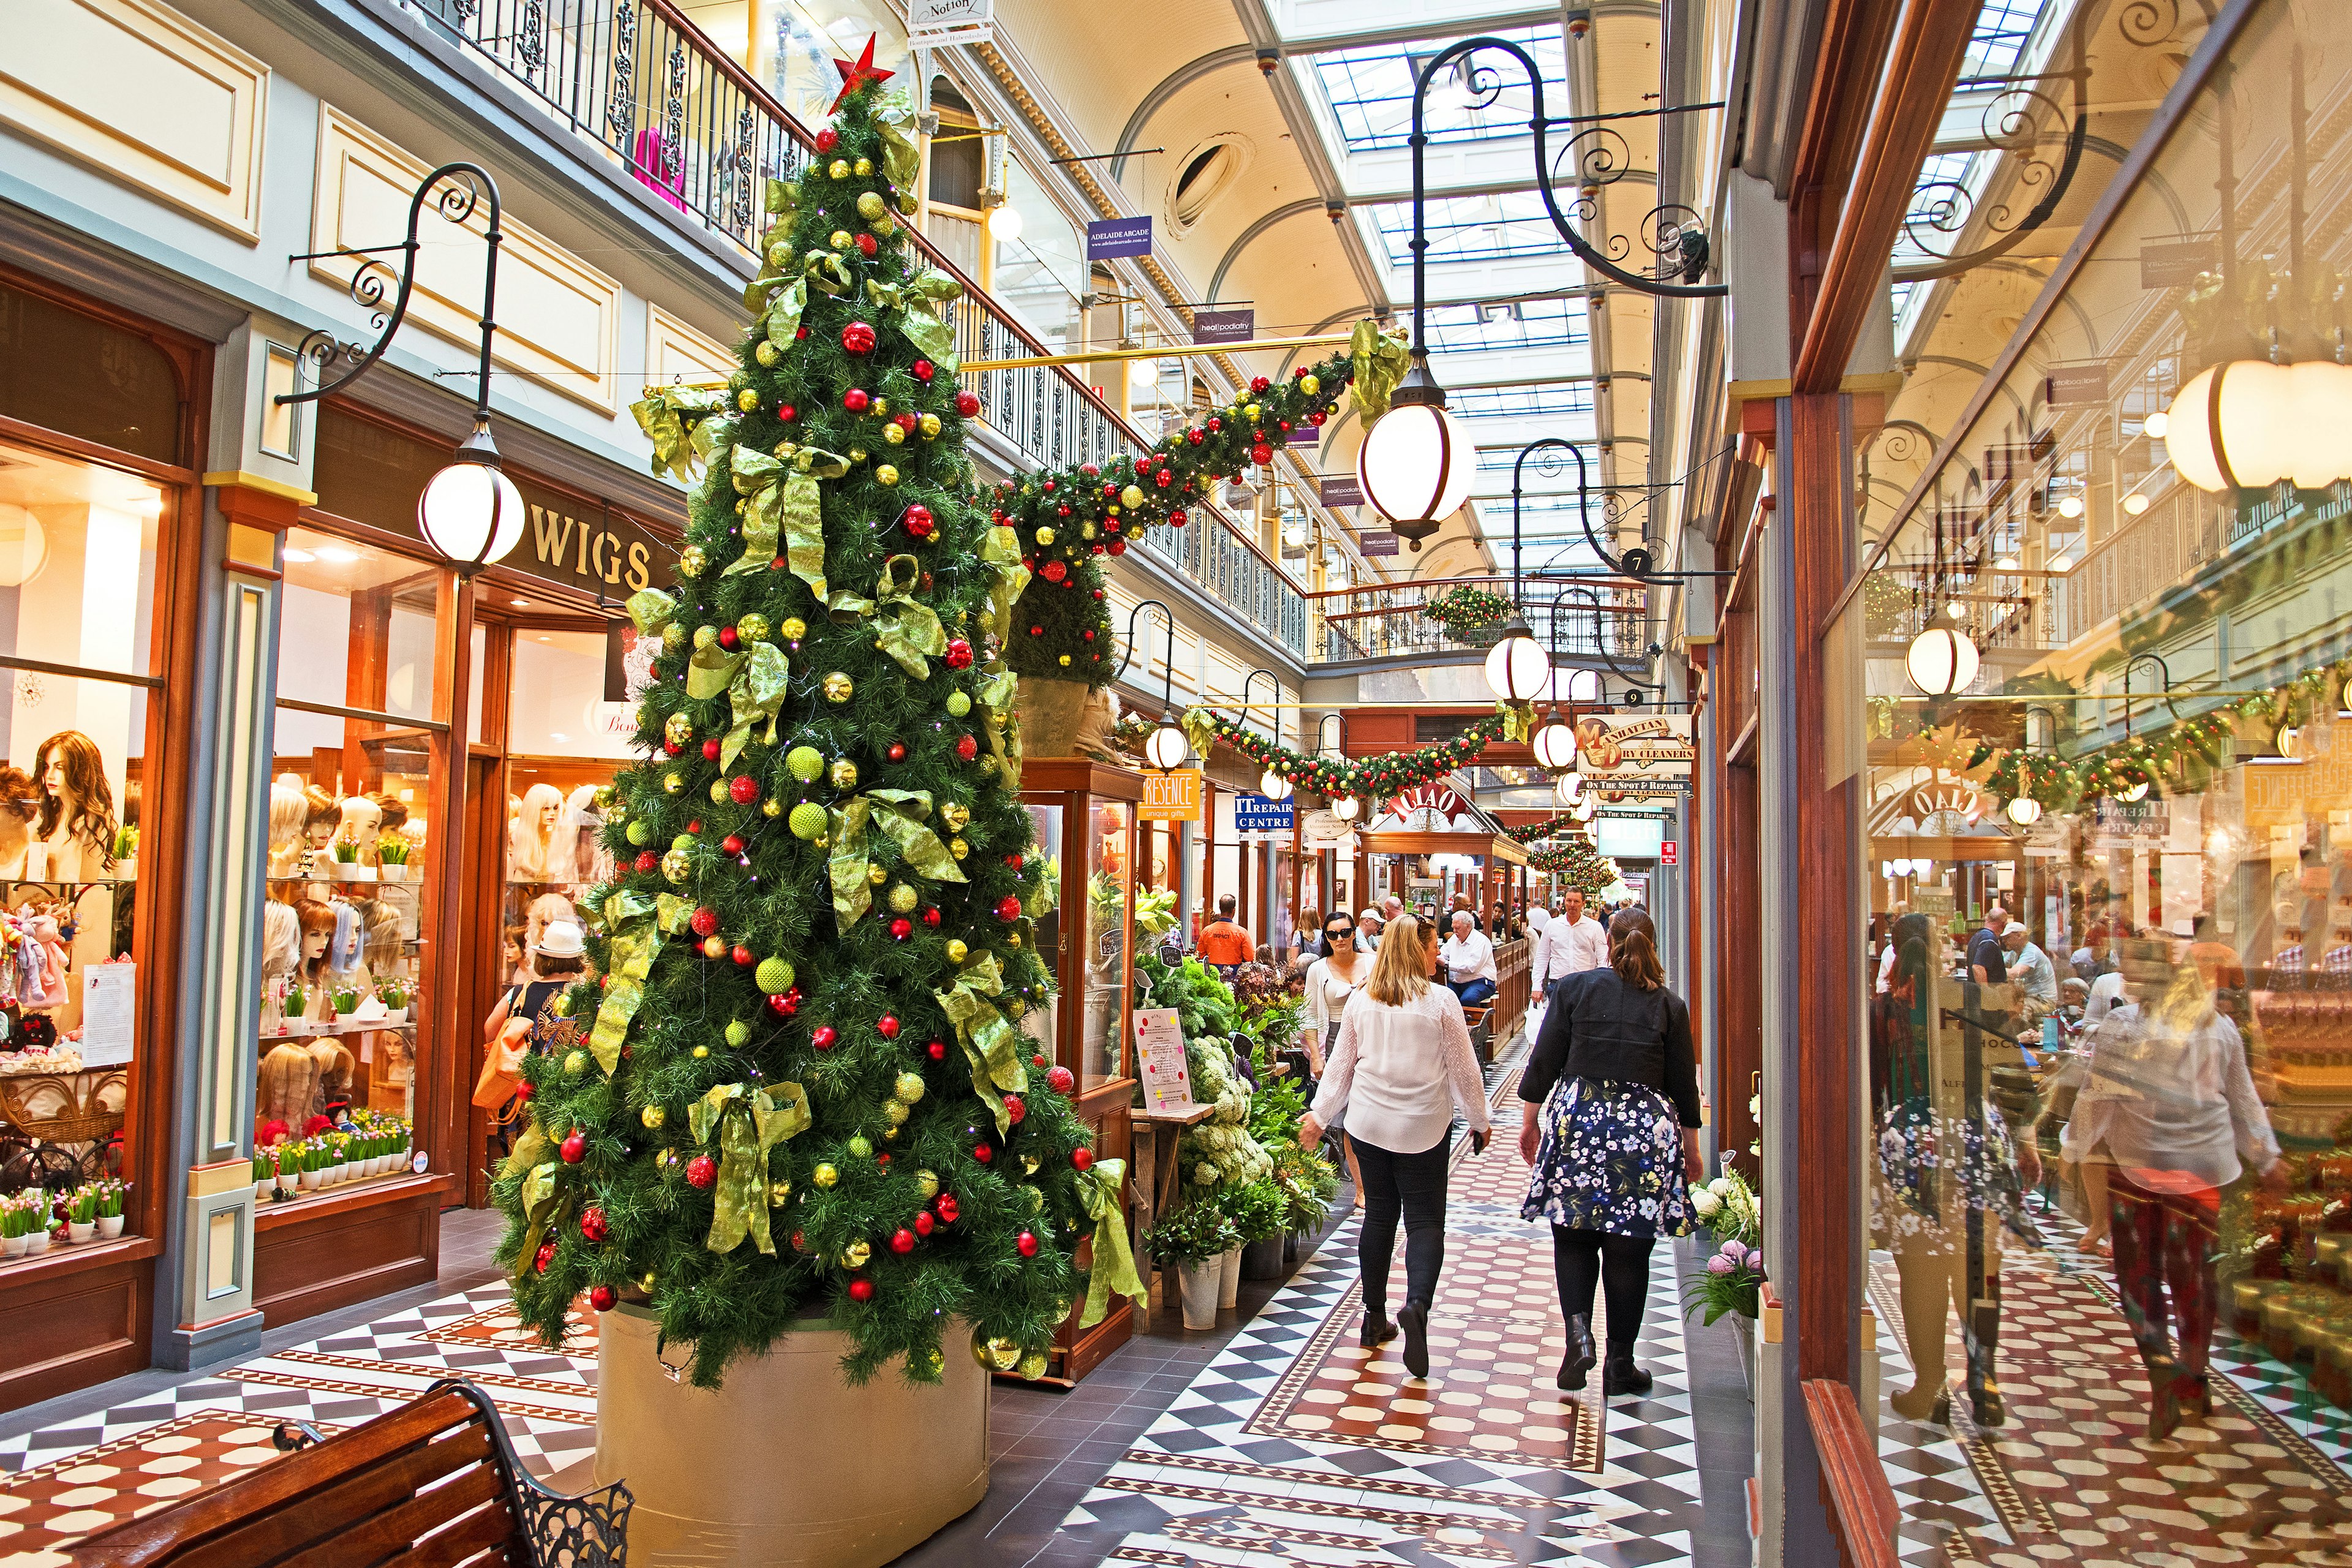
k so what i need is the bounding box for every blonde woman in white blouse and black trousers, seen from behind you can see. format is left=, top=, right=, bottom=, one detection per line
left=1298, top=917, right=1489, bottom=1378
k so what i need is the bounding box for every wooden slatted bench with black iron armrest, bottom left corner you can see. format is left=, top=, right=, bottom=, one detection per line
left=66, top=1378, right=630, bottom=1568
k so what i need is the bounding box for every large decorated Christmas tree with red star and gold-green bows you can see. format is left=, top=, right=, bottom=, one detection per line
left=496, top=66, right=1139, bottom=1385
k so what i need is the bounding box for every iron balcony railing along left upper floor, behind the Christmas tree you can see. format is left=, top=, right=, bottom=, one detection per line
left=409, top=0, right=1308, bottom=661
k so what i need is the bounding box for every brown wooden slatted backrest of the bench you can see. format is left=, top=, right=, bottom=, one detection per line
left=66, top=1389, right=532, bottom=1568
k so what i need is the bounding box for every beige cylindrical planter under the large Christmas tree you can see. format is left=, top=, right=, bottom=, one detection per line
left=595, top=1305, right=988, bottom=1568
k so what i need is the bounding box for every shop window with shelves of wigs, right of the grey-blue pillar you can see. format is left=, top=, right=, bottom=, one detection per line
left=254, top=529, right=447, bottom=1201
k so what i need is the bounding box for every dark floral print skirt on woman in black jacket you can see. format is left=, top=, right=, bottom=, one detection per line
left=1520, top=1079, right=1691, bottom=1237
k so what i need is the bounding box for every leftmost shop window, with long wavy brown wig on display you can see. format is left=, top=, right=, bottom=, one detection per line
left=0, top=435, right=174, bottom=1272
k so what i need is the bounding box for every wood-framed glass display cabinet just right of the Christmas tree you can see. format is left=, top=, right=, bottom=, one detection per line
left=1021, top=757, right=1143, bottom=1382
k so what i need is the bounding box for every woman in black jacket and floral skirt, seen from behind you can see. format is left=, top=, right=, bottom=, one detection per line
left=1520, top=910, right=1700, bottom=1399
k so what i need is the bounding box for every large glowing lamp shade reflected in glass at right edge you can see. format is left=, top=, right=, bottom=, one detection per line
left=2164, top=360, right=2352, bottom=491
